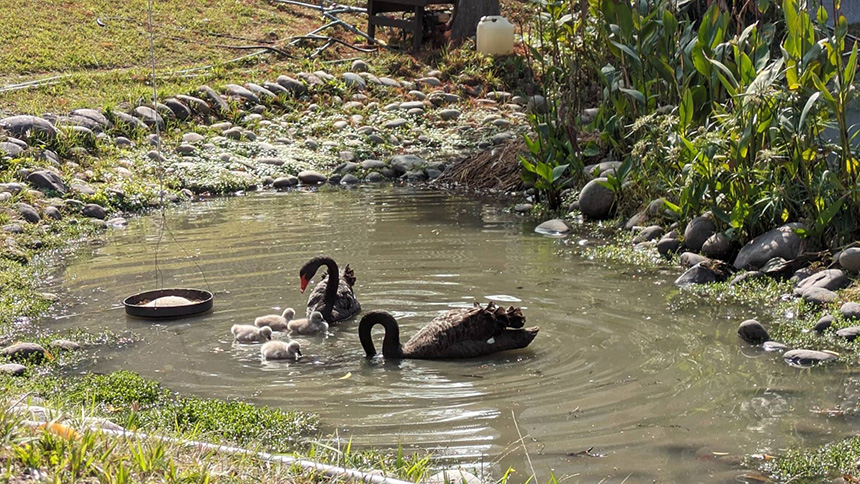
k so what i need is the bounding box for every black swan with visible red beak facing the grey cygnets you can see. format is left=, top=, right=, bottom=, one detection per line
left=299, top=257, right=361, bottom=324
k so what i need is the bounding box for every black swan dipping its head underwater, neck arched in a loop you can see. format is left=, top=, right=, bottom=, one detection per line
left=358, top=302, right=538, bottom=360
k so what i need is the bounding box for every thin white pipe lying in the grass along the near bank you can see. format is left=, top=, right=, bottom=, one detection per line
left=22, top=420, right=415, bottom=484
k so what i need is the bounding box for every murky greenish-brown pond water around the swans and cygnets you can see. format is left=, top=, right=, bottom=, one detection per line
left=46, top=188, right=858, bottom=483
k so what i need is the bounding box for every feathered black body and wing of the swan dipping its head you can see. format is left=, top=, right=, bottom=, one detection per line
left=403, top=303, right=537, bottom=359
